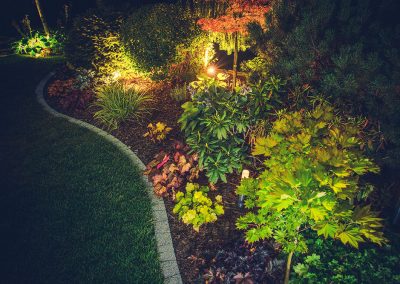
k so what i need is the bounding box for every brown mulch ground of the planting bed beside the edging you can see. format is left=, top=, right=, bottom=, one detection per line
left=45, top=69, right=278, bottom=283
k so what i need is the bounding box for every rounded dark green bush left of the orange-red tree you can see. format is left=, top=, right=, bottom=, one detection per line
left=121, top=4, right=198, bottom=76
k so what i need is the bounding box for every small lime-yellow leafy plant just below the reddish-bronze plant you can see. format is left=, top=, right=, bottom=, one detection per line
left=173, top=183, right=224, bottom=232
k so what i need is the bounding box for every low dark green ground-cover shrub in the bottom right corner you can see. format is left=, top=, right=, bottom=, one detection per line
left=291, top=232, right=400, bottom=284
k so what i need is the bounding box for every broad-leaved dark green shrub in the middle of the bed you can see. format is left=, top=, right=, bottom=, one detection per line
left=179, top=78, right=280, bottom=183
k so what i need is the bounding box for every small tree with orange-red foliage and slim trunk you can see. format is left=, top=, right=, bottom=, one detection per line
left=197, top=0, right=269, bottom=88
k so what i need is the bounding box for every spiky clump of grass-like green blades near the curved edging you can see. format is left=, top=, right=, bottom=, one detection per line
left=94, top=83, right=152, bottom=130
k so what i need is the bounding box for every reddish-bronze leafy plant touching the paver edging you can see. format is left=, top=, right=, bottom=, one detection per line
left=144, top=143, right=200, bottom=199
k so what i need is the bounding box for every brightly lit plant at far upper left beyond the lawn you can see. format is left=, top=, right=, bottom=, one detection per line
left=13, top=32, right=63, bottom=57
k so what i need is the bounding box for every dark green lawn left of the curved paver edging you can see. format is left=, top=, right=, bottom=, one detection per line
left=0, top=56, right=162, bottom=283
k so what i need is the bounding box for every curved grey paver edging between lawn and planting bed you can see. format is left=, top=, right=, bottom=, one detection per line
left=35, top=72, right=182, bottom=284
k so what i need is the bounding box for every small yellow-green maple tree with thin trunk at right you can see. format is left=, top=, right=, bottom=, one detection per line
left=237, top=103, right=386, bottom=281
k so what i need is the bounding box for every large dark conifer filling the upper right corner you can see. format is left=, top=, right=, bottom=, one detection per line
left=246, top=0, right=400, bottom=167
